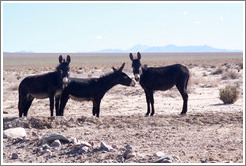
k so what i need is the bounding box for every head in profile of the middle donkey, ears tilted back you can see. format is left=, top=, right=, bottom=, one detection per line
left=112, top=63, right=135, bottom=86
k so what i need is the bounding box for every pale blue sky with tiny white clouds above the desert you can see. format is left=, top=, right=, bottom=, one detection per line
left=1, top=2, right=245, bottom=52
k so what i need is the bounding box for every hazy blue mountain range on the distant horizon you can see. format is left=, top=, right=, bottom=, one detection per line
left=96, top=44, right=242, bottom=53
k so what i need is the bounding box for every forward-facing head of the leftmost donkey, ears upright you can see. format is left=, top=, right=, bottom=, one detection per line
left=56, top=55, right=71, bottom=87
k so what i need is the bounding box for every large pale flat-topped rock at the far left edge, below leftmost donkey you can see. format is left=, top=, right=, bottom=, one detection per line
left=3, top=127, right=26, bottom=138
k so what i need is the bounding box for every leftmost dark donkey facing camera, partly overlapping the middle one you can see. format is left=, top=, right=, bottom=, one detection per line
left=18, top=55, right=71, bottom=117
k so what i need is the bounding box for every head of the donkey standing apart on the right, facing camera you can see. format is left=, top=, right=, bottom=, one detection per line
left=129, top=52, right=142, bottom=81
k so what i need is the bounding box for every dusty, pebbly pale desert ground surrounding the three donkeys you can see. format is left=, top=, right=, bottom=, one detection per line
left=1, top=54, right=244, bottom=163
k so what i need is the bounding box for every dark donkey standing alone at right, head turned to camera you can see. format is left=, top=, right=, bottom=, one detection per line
left=129, top=52, right=190, bottom=116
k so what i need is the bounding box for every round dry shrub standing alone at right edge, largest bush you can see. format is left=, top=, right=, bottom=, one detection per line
left=220, top=85, right=239, bottom=104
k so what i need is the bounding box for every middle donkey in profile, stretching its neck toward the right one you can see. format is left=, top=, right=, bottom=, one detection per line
left=60, top=63, right=135, bottom=117
